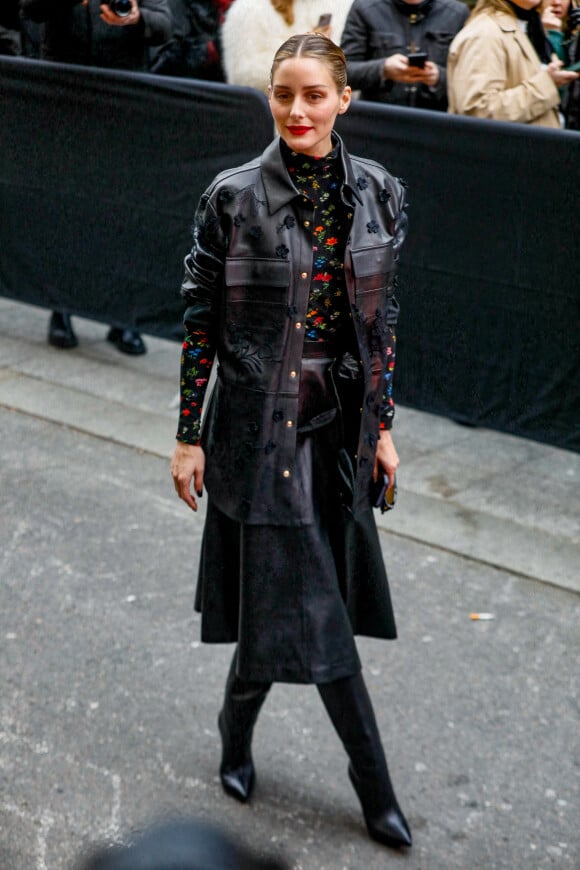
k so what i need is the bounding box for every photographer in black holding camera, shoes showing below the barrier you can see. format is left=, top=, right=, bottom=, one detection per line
left=20, top=0, right=173, bottom=355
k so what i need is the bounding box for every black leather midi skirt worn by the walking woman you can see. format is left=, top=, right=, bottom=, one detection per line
left=195, top=359, right=396, bottom=683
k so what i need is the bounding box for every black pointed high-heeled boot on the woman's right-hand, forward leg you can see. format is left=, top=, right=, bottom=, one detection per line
left=317, top=673, right=411, bottom=848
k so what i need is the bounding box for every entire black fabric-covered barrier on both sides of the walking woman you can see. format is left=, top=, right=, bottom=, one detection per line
left=0, top=58, right=580, bottom=450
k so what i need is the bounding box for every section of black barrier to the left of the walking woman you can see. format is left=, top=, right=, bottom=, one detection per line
left=0, top=58, right=273, bottom=338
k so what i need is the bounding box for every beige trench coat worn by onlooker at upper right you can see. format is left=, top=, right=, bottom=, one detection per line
left=447, top=11, right=561, bottom=127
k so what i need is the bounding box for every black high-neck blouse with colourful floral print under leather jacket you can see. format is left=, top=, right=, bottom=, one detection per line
left=177, top=142, right=395, bottom=444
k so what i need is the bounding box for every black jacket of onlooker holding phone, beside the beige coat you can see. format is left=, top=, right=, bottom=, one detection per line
left=341, top=0, right=469, bottom=112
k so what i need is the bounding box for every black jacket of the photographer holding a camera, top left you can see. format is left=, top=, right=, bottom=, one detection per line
left=21, top=0, right=173, bottom=70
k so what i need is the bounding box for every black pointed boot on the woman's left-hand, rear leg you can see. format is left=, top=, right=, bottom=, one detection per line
left=218, top=653, right=271, bottom=803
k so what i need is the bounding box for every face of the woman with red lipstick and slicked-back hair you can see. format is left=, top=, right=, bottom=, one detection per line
left=268, top=57, right=351, bottom=157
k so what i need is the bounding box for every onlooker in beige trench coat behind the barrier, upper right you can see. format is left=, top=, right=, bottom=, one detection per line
left=447, top=0, right=578, bottom=128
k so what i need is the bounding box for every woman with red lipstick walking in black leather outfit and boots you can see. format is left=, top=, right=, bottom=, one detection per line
left=172, top=34, right=411, bottom=847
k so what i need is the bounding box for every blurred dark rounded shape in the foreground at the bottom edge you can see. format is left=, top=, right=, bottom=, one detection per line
left=77, top=820, right=287, bottom=870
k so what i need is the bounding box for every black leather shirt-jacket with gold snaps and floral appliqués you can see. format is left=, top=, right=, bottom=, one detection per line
left=182, top=131, right=406, bottom=525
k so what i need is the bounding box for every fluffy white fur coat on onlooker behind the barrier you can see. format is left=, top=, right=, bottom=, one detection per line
left=222, top=0, right=352, bottom=92
